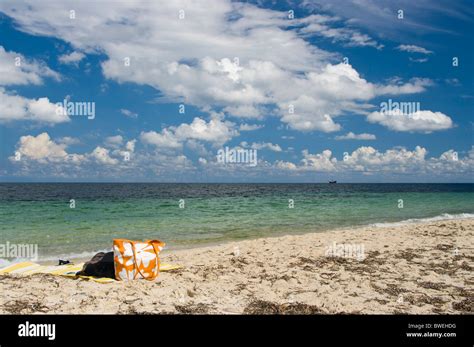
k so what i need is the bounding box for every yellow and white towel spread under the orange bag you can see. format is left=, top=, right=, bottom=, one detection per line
left=0, top=261, right=181, bottom=283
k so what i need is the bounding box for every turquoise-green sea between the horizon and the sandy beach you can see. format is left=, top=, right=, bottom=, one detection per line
left=0, top=183, right=474, bottom=260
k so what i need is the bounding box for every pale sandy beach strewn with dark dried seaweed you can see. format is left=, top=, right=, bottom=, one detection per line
left=0, top=219, right=474, bottom=314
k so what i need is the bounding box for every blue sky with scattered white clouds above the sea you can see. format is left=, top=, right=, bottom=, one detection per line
left=0, top=0, right=474, bottom=182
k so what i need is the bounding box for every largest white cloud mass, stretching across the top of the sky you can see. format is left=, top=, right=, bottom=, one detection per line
left=0, top=0, right=434, bottom=133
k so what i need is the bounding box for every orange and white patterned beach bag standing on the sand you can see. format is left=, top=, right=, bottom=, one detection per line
left=114, top=239, right=165, bottom=281
